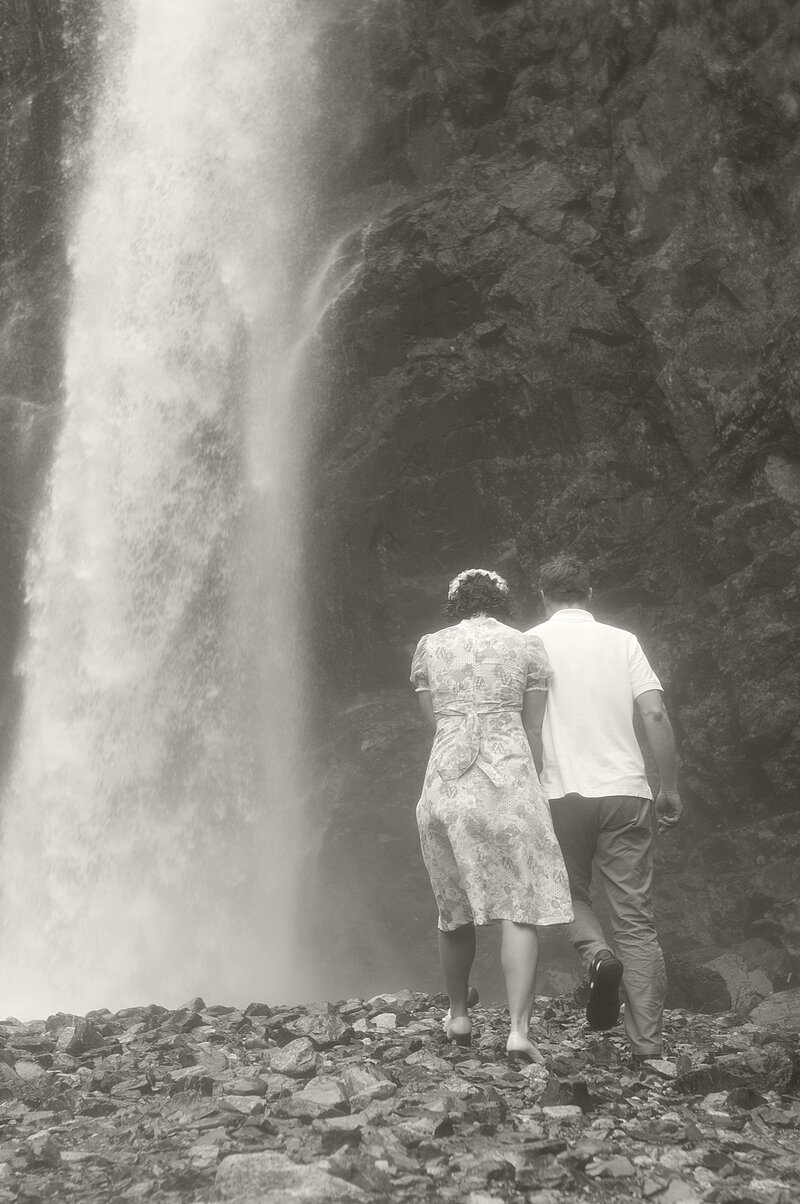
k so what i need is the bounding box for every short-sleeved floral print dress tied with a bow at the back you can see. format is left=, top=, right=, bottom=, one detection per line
left=411, top=616, right=572, bottom=932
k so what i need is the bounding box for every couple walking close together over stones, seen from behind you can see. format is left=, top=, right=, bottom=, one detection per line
left=411, top=556, right=681, bottom=1062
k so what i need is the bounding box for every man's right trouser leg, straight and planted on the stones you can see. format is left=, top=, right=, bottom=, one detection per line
left=595, top=797, right=666, bottom=1057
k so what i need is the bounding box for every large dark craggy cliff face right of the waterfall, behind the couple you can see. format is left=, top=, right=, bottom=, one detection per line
left=304, top=0, right=800, bottom=985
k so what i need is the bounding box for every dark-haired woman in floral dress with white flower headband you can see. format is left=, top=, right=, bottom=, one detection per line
left=411, top=568, right=572, bottom=1062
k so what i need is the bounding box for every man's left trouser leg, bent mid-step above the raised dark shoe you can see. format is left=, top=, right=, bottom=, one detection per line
left=551, top=795, right=608, bottom=970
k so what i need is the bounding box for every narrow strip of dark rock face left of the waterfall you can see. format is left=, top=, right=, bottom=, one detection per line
left=0, top=0, right=96, bottom=762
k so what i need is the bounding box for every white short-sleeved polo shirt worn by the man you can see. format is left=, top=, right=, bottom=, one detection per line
left=531, top=607, right=661, bottom=798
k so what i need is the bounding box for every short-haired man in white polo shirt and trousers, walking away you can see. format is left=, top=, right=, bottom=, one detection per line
left=533, top=556, right=682, bottom=1062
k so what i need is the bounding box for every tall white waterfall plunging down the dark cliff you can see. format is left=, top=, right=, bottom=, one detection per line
left=0, top=0, right=324, bottom=1016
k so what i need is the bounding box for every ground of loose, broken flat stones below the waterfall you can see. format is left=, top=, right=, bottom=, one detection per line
left=0, top=991, right=800, bottom=1204
